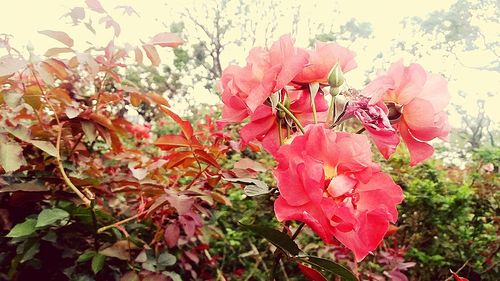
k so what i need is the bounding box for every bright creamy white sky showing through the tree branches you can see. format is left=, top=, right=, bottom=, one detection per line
left=0, top=0, right=500, bottom=126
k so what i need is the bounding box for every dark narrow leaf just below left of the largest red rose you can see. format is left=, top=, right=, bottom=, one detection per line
left=241, top=224, right=300, bottom=256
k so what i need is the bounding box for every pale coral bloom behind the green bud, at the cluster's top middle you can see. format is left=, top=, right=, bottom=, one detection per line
left=293, top=41, right=357, bottom=84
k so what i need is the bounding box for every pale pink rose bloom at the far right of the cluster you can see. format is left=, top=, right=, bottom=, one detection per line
left=361, top=61, right=450, bottom=165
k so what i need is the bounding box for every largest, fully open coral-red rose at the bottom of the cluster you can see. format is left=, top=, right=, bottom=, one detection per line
left=274, top=124, right=403, bottom=261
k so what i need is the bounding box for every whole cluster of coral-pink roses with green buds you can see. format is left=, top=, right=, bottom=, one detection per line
left=218, top=35, right=449, bottom=261
